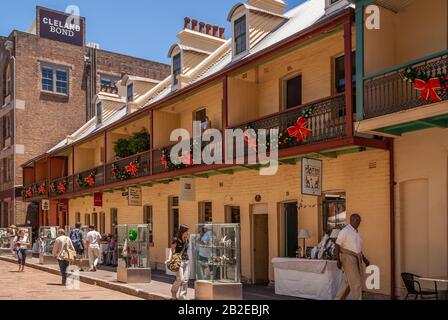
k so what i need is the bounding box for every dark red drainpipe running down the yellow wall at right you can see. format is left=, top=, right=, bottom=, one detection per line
left=389, top=139, right=396, bottom=300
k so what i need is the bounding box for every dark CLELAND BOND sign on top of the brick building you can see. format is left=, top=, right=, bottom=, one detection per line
left=36, top=7, right=85, bottom=46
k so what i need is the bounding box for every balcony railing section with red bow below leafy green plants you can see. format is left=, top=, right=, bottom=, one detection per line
left=106, top=151, right=151, bottom=184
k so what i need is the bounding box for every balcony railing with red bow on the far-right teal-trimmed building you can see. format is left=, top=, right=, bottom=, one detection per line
left=364, top=53, right=448, bottom=119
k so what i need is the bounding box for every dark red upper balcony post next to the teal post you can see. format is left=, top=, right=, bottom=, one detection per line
left=344, top=16, right=353, bottom=137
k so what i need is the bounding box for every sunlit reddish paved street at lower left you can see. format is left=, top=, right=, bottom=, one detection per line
left=0, top=260, right=142, bottom=300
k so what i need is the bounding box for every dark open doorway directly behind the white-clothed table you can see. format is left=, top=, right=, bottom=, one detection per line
left=279, top=202, right=299, bottom=258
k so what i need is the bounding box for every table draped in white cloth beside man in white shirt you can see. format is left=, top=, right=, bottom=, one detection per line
left=272, top=258, right=345, bottom=300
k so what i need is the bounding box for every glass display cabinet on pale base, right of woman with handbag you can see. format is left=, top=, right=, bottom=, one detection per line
left=194, top=224, right=243, bottom=300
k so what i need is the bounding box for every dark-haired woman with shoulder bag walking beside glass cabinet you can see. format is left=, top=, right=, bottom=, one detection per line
left=166, top=225, right=190, bottom=300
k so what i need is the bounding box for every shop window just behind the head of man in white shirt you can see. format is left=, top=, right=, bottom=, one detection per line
left=322, top=193, right=347, bottom=234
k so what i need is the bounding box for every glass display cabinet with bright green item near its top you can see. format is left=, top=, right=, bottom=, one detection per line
left=117, top=224, right=151, bottom=283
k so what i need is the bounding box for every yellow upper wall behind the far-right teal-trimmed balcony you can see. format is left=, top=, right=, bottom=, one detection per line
left=365, top=0, right=448, bottom=74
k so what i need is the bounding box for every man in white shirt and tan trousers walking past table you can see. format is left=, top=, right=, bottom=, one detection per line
left=335, top=214, right=370, bottom=300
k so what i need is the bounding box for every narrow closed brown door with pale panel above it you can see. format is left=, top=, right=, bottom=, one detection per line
left=251, top=205, right=269, bottom=285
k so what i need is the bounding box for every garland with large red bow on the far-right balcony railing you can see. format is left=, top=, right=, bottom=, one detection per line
left=402, top=68, right=448, bottom=104
